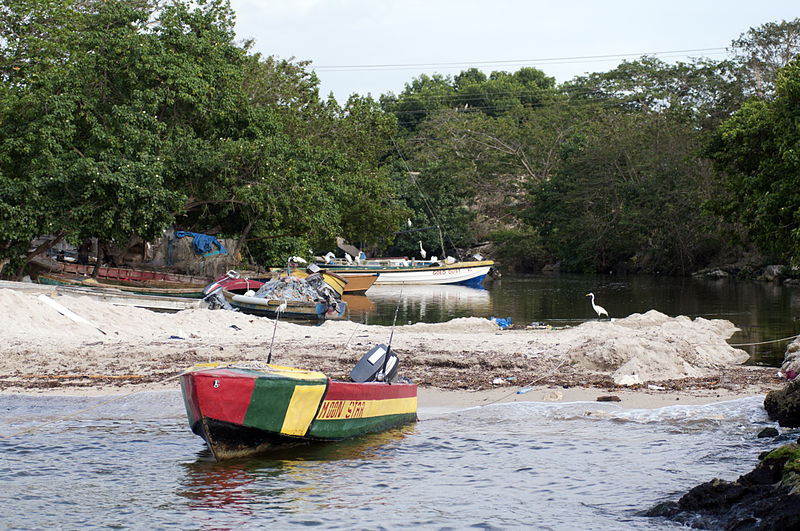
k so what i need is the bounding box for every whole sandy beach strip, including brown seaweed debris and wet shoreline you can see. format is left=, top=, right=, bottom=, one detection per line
left=0, top=289, right=785, bottom=411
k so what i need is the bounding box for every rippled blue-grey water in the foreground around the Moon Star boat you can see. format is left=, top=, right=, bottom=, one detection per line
left=0, top=391, right=797, bottom=529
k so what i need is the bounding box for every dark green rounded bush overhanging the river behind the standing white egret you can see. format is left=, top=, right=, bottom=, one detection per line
left=526, top=113, right=719, bottom=273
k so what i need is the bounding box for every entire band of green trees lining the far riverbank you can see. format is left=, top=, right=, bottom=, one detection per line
left=0, top=0, right=800, bottom=277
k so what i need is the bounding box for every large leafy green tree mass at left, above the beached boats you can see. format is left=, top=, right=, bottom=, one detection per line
left=0, top=0, right=405, bottom=274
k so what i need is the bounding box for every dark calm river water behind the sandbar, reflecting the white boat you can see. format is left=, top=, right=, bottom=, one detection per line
left=346, top=275, right=800, bottom=366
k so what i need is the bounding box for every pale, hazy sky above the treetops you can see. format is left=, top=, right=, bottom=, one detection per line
left=231, top=0, right=800, bottom=103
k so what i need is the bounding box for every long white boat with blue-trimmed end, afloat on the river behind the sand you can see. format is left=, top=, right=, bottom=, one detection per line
left=318, top=258, right=494, bottom=286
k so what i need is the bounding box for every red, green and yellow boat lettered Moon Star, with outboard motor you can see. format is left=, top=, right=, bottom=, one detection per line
left=180, top=345, right=417, bottom=460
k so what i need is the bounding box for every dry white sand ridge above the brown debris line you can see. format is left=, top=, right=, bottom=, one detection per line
left=0, top=289, right=748, bottom=385
